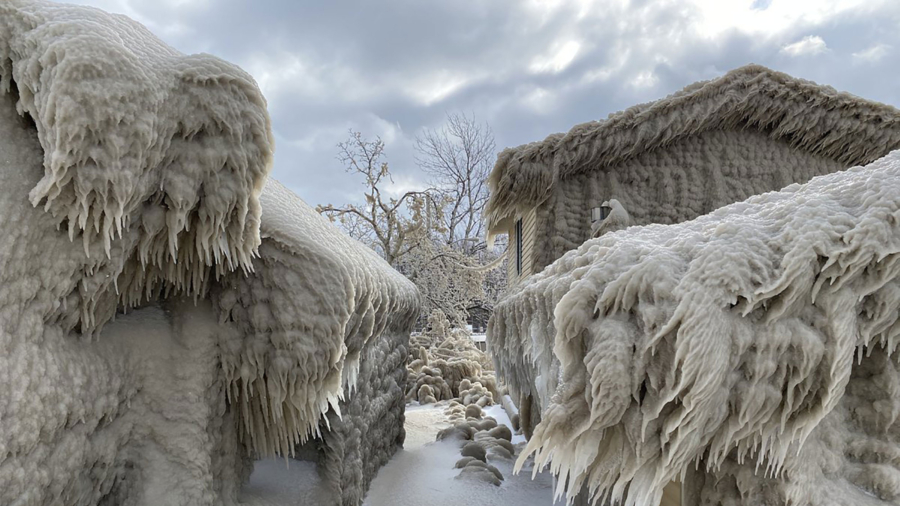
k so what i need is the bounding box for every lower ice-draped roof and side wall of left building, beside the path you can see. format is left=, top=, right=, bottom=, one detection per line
left=227, top=180, right=420, bottom=505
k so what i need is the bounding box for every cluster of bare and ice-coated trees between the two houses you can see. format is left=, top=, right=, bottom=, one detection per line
left=317, top=119, right=506, bottom=326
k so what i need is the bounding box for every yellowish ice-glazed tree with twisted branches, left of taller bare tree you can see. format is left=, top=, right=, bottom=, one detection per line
left=316, top=131, right=442, bottom=265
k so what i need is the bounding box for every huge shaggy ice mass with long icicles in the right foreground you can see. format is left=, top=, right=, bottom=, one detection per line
left=488, top=153, right=900, bottom=505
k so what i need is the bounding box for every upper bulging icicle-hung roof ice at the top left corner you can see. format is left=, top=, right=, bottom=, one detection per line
left=0, top=0, right=274, bottom=330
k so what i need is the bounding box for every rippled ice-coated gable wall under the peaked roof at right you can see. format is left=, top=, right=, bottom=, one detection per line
left=536, top=130, right=846, bottom=272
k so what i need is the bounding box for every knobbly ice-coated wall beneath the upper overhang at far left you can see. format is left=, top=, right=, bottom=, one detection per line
left=0, top=87, right=250, bottom=505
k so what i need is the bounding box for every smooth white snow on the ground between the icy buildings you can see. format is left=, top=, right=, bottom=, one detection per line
left=241, top=404, right=553, bottom=506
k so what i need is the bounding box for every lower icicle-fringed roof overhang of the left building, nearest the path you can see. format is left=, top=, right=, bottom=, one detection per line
left=213, top=180, right=419, bottom=455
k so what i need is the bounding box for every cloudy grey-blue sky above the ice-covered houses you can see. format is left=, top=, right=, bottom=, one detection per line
left=68, top=0, right=900, bottom=205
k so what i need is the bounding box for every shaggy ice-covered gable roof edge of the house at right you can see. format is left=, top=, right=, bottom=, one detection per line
left=485, top=65, right=900, bottom=233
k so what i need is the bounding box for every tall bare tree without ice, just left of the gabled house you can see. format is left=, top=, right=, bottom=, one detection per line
left=415, top=113, right=495, bottom=254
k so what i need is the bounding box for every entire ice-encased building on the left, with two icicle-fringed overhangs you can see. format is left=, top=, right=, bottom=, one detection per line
left=0, top=0, right=419, bottom=505
